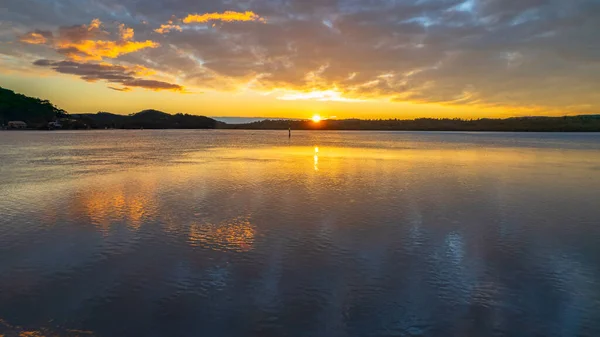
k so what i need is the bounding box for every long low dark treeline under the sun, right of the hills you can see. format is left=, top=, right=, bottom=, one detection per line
left=227, top=115, right=600, bottom=132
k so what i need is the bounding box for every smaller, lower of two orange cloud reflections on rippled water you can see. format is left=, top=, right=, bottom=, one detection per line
left=188, top=217, right=256, bottom=252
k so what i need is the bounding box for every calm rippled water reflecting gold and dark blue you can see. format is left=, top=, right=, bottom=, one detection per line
left=0, top=130, right=600, bottom=337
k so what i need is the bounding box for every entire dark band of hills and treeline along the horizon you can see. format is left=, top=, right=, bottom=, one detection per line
left=0, top=87, right=600, bottom=132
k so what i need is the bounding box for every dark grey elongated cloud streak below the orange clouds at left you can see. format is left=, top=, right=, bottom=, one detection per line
left=33, top=59, right=184, bottom=92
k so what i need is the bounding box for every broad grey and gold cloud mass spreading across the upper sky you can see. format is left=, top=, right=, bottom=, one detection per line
left=7, top=0, right=600, bottom=113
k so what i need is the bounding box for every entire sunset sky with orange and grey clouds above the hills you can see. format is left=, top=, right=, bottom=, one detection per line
left=0, top=0, right=600, bottom=119
